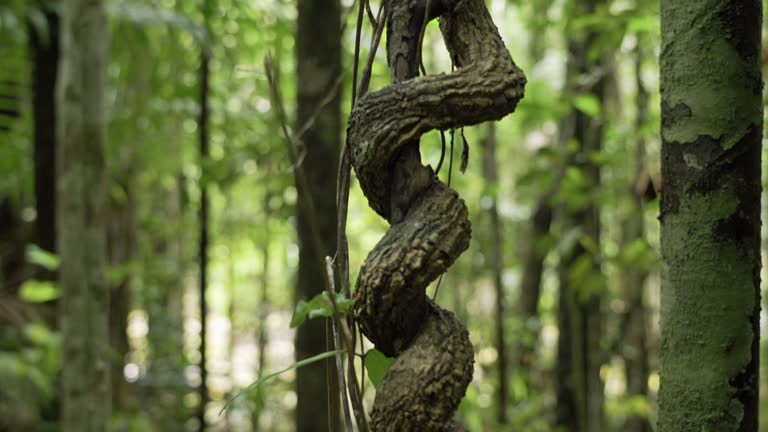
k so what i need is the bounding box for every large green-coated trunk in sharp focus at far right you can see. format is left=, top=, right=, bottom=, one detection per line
left=658, top=0, right=763, bottom=432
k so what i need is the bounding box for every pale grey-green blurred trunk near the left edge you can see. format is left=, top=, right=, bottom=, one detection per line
left=56, top=0, right=111, bottom=432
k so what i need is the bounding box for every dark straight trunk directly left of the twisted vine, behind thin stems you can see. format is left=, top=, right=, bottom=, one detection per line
left=296, top=0, right=342, bottom=432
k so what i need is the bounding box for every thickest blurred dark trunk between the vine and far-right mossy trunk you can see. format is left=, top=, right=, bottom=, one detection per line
left=556, top=0, right=605, bottom=432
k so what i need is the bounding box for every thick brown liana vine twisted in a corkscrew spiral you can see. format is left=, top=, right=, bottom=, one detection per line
left=348, top=0, right=525, bottom=426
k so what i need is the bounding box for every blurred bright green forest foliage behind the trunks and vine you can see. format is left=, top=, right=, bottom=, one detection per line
left=0, top=0, right=768, bottom=432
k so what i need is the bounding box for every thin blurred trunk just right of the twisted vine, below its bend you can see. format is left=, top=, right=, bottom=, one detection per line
left=483, top=123, right=509, bottom=424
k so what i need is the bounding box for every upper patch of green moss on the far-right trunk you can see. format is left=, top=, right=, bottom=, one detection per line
left=661, top=0, right=762, bottom=149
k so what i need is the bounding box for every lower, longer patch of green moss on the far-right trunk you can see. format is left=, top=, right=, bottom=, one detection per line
left=659, top=184, right=756, bottom=432
